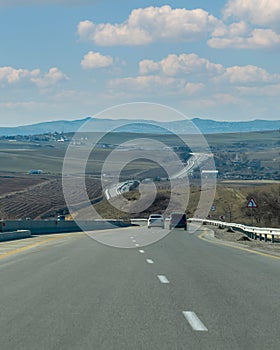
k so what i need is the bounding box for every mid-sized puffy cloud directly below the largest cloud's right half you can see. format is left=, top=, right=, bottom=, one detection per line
left=139, top=53, right=223, bottom=76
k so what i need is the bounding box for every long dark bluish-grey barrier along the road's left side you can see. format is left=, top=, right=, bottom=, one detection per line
left=0, top=220, right=131, bottom=234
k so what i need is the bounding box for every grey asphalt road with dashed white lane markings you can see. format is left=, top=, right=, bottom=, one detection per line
left=0, top=227, right=280, bottom=350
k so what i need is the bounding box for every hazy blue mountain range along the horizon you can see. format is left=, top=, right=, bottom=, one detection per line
left=0, top=117, right=280, bottom=136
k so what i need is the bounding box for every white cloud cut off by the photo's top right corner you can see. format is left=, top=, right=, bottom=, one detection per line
left=224, top=0, right=280, bottom=25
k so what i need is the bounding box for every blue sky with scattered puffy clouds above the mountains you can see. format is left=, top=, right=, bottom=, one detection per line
left=0, top=0, right=280, bottom=126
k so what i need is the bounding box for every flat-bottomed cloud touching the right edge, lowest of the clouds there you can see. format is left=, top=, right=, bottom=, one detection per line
left=216, top=65, right=280, bottom=84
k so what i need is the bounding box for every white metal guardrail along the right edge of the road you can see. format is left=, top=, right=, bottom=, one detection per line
left=188, top=218, right=280, bottom=243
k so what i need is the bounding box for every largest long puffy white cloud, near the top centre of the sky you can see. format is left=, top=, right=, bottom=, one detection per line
left=78, top=5, right=220, bottom=46
